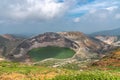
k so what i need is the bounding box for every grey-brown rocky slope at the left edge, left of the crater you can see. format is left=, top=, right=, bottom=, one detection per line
left=0, top=34, right=23, bottom=57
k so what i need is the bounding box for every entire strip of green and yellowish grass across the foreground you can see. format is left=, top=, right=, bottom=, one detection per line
left=0, top=62, right=120, bottom=80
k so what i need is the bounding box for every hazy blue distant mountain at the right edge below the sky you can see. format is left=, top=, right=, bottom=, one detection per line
left=90, top=28, right=120, bottom=36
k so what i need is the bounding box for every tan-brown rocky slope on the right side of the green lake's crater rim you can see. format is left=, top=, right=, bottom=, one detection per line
left=59, top=32, right=110, bottom=59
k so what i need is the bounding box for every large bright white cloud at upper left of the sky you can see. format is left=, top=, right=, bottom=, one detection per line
left=9, top=0, right=68, bottom=19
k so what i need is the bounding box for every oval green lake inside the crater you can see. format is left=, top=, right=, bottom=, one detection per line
left=28, top=46, right=75, bottom=61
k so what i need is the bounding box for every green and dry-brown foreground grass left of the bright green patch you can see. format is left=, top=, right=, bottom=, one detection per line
left=0, top=62, right=70, bottom=80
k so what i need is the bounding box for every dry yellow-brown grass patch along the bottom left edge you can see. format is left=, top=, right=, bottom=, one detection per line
left=0, top=72, right=57, bottom=80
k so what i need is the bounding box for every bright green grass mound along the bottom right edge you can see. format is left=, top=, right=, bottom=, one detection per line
left=52, top=71, right=120, bottom=80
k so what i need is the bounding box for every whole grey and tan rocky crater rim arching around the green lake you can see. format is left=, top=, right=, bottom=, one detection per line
left=8, top=32, right=110, bottom=61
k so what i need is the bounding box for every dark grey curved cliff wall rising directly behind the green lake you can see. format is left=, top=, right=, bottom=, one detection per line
left=9, top=32, right=79, bottom=60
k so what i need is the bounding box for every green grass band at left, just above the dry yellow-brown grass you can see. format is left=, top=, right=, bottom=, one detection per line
left=0, top=61, right=45, bottom=74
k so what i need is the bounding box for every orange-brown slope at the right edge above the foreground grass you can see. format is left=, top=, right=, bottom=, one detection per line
left=93, top=48, right=120, bottom=67
